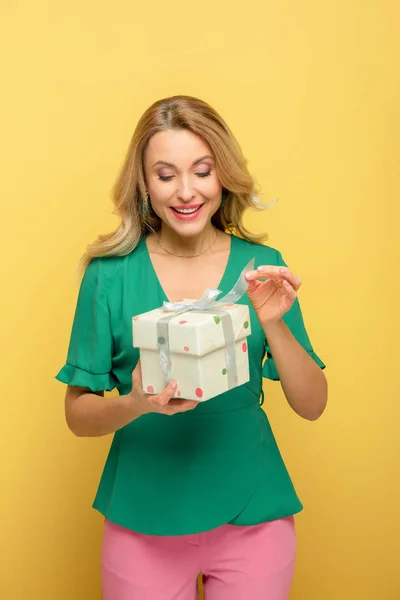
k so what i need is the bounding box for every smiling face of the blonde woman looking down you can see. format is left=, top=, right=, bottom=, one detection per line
left=144, top=129, right=222, bottom=237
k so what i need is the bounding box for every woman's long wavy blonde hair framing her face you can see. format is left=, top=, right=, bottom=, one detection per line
left=80, top=96, right=269, bottom=271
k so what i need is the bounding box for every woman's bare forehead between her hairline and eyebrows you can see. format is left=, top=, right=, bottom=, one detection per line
left=145, top=129, right=213, bottom=165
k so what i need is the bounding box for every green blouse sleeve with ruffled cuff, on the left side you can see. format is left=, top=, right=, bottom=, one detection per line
left=56, top=258, right=116, bottom=392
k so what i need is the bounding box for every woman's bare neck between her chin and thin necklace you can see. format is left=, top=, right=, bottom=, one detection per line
left=157, top=223, right=218, bottom=257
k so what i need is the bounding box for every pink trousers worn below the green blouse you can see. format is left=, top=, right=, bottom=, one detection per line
left=102, top=517, right=296, bottom=600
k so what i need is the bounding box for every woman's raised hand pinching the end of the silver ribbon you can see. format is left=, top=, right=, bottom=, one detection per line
left=246, top=265, right=302, bottom=327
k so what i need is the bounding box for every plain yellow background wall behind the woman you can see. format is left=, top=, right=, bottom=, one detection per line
left=0, top=0, right=400, bottom=600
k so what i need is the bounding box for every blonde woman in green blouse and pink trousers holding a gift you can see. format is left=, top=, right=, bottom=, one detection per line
left=57, top=96, right=327, bottom=600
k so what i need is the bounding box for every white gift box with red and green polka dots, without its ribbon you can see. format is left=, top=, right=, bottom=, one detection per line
left=132, top=300, right=251, bottom=402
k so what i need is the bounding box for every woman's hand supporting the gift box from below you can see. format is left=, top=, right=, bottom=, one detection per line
left=129, top=360, right=199, bottom=416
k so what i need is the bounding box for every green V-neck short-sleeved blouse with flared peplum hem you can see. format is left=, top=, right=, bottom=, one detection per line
left=57, top=236, right=325, bottom=535
